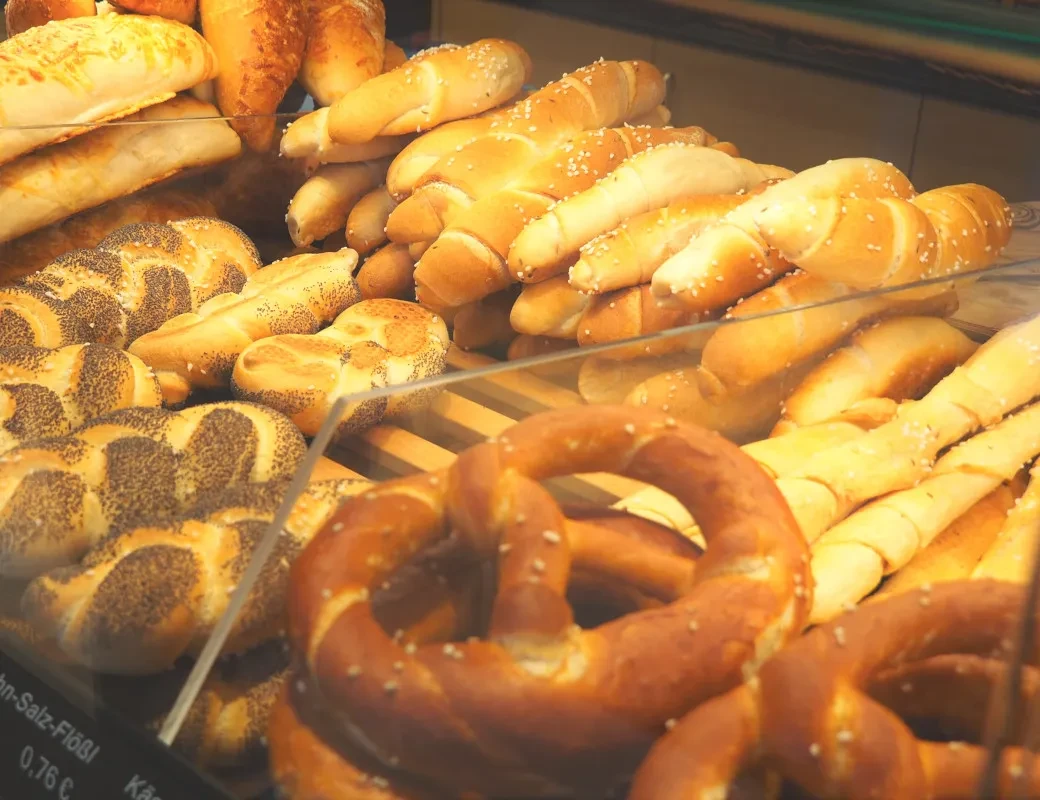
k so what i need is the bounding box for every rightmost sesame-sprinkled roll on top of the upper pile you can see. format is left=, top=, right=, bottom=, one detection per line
left=754, top=183, right=1011, bottom=289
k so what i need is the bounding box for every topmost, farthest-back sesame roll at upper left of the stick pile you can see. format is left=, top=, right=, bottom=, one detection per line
left=329, top=38, right=531, bottom=145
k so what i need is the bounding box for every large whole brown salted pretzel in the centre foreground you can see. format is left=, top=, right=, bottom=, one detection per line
left=289, top=407, right=811, bottom=797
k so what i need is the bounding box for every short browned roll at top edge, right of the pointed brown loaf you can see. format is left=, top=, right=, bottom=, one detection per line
left=300, top=0, right=387, bottom=106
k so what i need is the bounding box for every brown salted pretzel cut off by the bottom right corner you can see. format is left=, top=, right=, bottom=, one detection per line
left=629, top=580, right=1040, bottom=800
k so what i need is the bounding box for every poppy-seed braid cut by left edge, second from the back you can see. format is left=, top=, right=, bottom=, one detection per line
left=0, top=344, right=162, bottom=453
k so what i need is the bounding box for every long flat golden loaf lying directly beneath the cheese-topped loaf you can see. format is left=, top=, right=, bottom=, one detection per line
left=0, top=95, right=241, bottom=243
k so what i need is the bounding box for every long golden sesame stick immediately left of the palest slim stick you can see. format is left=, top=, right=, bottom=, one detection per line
left=409, top=127, right=716, bottom=306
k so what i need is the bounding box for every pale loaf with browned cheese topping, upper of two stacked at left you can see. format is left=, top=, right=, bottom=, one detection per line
left=0, top=15, right=217, bottom=165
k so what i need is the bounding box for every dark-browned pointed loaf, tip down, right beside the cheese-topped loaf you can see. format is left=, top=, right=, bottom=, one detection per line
left=199, top=0, right=307, bottom=151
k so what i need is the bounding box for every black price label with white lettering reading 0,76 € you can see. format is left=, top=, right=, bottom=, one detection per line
left=0, top=638, right=231, bottom=800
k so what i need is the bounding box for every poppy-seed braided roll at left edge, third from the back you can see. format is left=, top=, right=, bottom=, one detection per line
left=0, top=403, right=306, bottom=577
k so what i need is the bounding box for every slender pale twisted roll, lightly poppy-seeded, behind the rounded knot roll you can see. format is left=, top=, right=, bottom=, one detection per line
left=130, top=248, right=361, bottom=401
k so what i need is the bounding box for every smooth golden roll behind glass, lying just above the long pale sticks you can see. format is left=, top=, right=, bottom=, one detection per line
left=777, top=316, right=978, bottom=432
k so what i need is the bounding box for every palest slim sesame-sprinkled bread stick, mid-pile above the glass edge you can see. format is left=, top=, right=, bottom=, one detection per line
left=510, top=144, right=791, bottom=283
